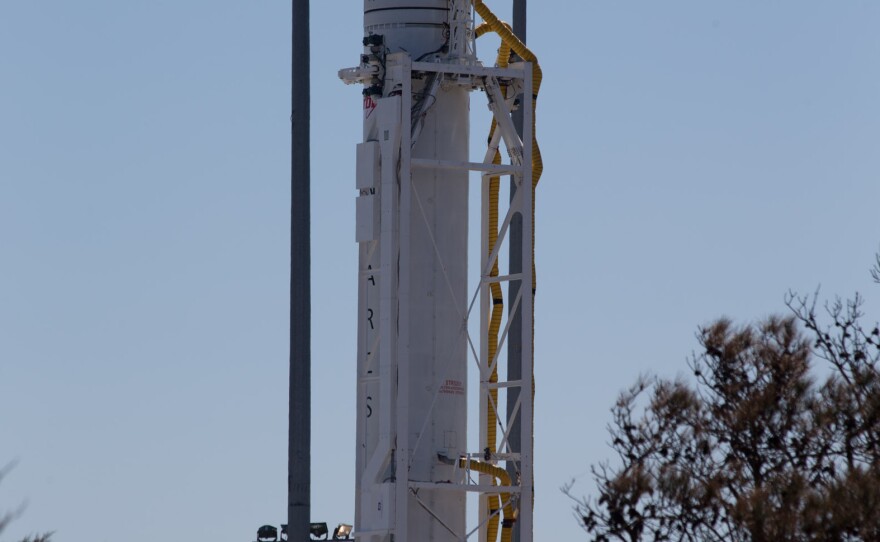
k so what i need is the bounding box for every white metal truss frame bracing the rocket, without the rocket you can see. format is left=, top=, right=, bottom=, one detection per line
left=340, top=47, right=534, bottom=542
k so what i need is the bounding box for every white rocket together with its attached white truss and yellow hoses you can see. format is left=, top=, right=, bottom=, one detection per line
left=340, top=0, right=539, bottom=542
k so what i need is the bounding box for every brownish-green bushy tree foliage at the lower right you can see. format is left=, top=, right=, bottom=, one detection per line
left=564, top=255, right=880, bottom=542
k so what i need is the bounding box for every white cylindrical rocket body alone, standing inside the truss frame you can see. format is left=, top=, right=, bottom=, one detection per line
left=355, top=0, right=470, bottom=542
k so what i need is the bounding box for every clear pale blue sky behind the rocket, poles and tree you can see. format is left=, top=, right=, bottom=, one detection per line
left=0, top=0, right=880, bottom=542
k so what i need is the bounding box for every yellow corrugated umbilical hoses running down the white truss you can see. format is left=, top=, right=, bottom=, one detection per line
left=472, top=0, right=544, bottom=542
